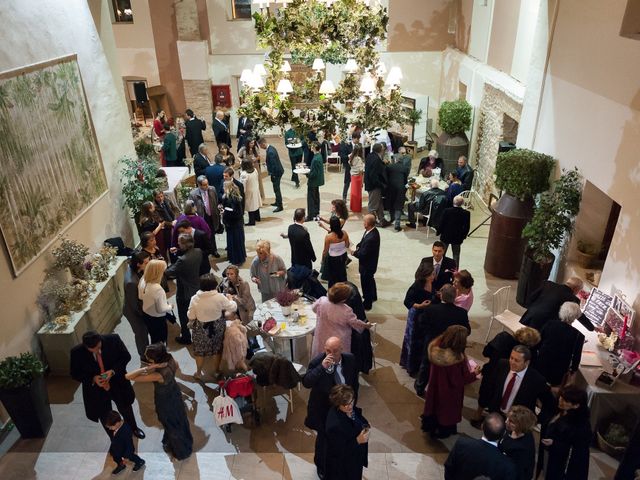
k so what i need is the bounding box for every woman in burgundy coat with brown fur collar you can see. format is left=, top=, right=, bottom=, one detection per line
left=422, top=325, right=476, bottom=438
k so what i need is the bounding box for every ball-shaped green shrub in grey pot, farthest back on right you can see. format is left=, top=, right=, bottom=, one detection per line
left=437, top=100, right=471, bottom=172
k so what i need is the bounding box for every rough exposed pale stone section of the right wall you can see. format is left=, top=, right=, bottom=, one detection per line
left=474, top=83, right=522, bottom=204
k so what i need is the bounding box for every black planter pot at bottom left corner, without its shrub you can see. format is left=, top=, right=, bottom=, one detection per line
left=0, top=377, right=53, bottom=438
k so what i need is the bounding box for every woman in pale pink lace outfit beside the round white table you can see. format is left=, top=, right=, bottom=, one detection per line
left=311, top=282, right=371, bottom=358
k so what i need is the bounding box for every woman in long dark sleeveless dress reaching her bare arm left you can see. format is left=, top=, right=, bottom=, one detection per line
left=126, top=343, right=193, bottom=460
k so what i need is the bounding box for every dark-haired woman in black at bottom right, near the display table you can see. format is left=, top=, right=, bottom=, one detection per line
left=538, top=385, right=592, bottom=480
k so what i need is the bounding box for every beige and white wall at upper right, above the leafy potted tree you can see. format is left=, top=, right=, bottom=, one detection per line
left=521, top=0, right=640, bottom=310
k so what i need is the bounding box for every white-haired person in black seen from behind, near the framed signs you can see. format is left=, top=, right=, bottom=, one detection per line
left=534, top=302, right=584, bottom=387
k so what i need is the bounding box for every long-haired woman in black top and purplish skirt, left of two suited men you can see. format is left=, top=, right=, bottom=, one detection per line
left=400, top=263, right=437, bottom=375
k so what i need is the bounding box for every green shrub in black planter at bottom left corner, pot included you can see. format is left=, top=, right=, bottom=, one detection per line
left=0, top=353, right=53, bottom=438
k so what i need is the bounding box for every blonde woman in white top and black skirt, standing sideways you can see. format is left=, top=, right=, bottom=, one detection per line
left=138, top=260, right=173, bottom=343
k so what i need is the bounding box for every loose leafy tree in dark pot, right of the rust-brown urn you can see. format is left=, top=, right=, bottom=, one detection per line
left=516, top=168, right=582, bottom=306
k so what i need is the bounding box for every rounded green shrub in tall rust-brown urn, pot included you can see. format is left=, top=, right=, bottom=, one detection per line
left=484, top=148, right=556, bottom=278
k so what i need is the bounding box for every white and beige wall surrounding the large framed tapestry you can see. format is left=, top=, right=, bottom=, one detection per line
left=0, top=0, right=134, bottom=358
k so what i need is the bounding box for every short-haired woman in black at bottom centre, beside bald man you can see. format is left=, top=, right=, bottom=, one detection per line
left=324, top=385, right=370, bottom=480
